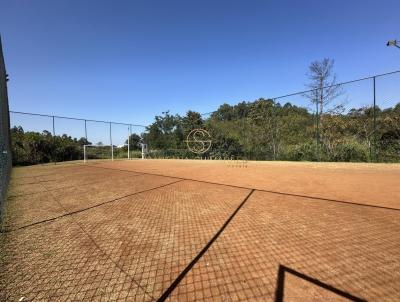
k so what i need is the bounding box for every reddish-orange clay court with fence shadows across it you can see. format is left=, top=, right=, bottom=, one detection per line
left=0, top=160, right=400, bottom=301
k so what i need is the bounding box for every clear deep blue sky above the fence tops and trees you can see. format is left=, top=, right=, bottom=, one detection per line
left=0, top=0, right=400, bottom=143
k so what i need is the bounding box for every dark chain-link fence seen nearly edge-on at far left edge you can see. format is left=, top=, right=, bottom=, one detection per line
left=0, top=39, right=11, bottom=221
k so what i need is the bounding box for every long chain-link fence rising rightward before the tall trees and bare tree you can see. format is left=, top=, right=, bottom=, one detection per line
left=139, top=71, right=400, bottom=162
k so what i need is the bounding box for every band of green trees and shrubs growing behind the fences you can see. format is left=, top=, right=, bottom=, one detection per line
left=11, top=99, right=400, bottom=165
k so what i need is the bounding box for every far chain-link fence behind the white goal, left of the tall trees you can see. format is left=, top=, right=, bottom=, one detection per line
left=10, top=111, right=146, bottom=165
